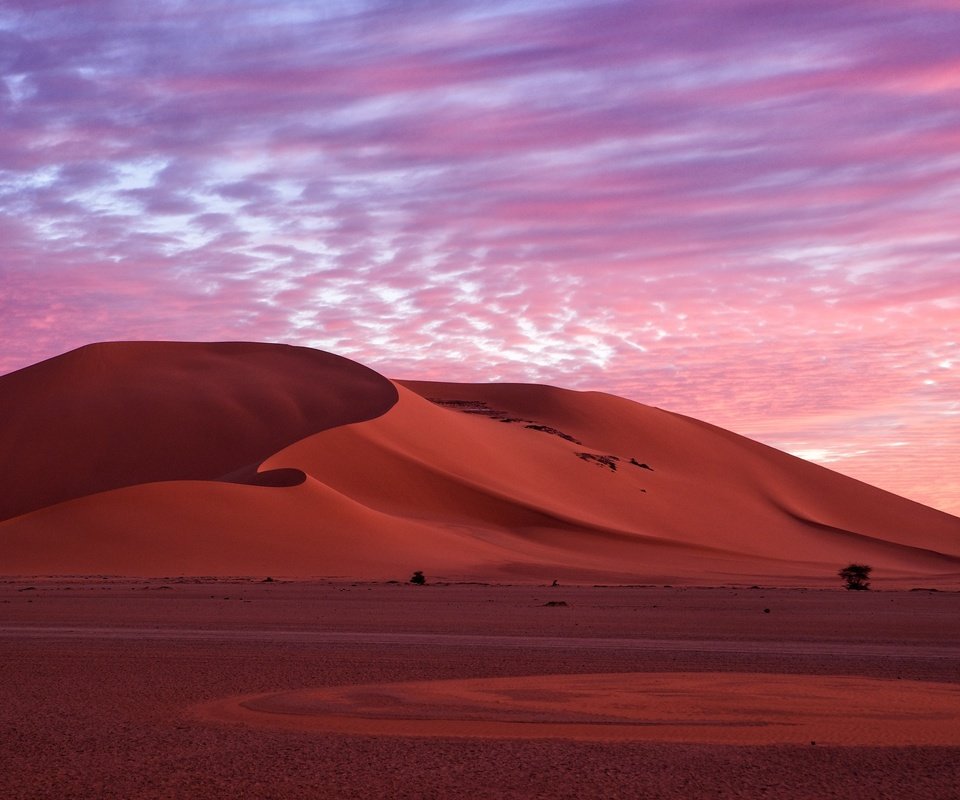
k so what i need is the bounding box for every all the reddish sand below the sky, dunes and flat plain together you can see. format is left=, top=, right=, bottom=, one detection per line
left=0, top=342, right=960, bottom=800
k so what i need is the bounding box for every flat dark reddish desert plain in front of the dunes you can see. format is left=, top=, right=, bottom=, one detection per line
left=0, top=577, right=960, bottom=800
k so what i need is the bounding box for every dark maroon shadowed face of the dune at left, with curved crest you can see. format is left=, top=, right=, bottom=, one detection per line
left=0, top=342, right=397, bottom=520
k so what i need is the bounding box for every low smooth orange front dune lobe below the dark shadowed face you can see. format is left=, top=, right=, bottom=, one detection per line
left=0, top=470, right=502, bottom=580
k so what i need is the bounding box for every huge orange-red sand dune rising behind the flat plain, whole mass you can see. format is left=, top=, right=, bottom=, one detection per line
left=0, top=343, right=960, bottom=585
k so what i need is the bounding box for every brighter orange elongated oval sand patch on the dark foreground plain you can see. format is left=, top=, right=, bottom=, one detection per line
left=199, top=672, right=960, bottom=746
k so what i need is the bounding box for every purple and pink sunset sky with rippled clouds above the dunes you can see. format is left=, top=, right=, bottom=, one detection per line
left=0, top=0, right=960, bottom=514
